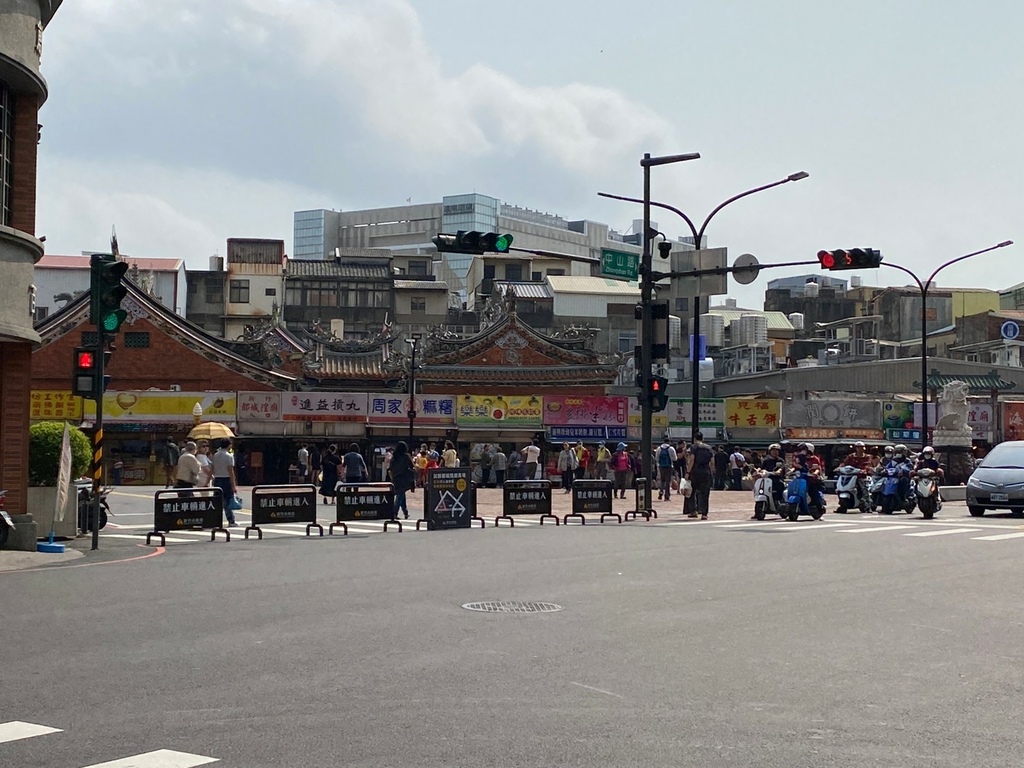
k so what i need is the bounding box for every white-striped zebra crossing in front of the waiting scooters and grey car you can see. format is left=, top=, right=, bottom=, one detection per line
left=657, top=518, right=1024, bottom=542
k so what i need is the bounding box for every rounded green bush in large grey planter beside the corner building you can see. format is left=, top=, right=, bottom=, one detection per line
left=28, top=421, right=92, bottom=539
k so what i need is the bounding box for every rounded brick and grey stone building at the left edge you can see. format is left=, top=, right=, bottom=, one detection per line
left=0, top=0, right=61, bottom=528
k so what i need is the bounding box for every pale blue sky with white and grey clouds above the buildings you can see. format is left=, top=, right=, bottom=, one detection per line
left=37, top=0, right=1024, bottom=307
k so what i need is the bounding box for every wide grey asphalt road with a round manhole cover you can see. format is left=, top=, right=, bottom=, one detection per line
left=0, top=495, right=1024, bottom=768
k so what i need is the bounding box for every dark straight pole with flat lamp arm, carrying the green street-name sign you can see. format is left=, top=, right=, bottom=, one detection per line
left=637, top=153, right=700, bottom=517
